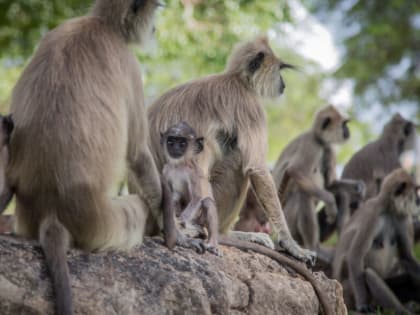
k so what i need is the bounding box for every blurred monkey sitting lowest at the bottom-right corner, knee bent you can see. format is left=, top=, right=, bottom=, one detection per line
left=333, top=169, right=420, bottom=314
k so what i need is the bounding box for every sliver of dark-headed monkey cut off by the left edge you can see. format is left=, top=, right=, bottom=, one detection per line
left=0, top=115, right=14, bottom=214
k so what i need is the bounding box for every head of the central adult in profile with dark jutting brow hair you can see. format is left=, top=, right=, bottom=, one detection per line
left=226, top=37, right=294, bottom=97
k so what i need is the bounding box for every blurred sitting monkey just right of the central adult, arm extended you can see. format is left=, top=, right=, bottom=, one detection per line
left=273, top=105, right=350, bottom=261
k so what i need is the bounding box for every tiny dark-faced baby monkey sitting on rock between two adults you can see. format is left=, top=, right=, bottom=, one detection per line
left=161, top=122, right=220, bottom=255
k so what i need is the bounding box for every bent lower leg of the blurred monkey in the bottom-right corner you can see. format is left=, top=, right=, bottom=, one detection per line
left=365, top=268, right=411, bottom=315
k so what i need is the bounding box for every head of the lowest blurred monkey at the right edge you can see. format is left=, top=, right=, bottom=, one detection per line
left=379, top=168, right=417, bottom=215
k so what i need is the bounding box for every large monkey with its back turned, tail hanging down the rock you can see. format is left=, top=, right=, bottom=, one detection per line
left=7, top=0, right=161, bottom=315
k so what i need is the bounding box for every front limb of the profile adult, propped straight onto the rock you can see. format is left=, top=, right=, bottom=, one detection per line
left=247, top=167, right=316, bottom=265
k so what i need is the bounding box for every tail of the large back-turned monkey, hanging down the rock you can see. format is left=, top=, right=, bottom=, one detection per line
left=39, top=215, right=73, bottom=315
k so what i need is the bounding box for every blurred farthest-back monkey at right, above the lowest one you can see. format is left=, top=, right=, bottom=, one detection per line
left=341, top=114, right=416, bottom=206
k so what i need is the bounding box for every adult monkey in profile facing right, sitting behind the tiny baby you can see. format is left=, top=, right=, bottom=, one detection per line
left=148, top=38, right=315, bottom=263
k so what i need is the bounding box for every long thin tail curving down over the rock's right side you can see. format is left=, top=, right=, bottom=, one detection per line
left=219, top=235, right=333, bottom=315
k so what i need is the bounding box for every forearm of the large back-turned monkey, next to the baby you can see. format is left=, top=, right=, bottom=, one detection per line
left=128, top=145, right=163, bottom=230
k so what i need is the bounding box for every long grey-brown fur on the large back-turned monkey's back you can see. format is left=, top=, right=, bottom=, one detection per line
left=8, top=17, right=133, bottom=243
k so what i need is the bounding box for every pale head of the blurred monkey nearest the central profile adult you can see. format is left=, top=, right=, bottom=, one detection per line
left=312, top=105, right=350, bottom=143
